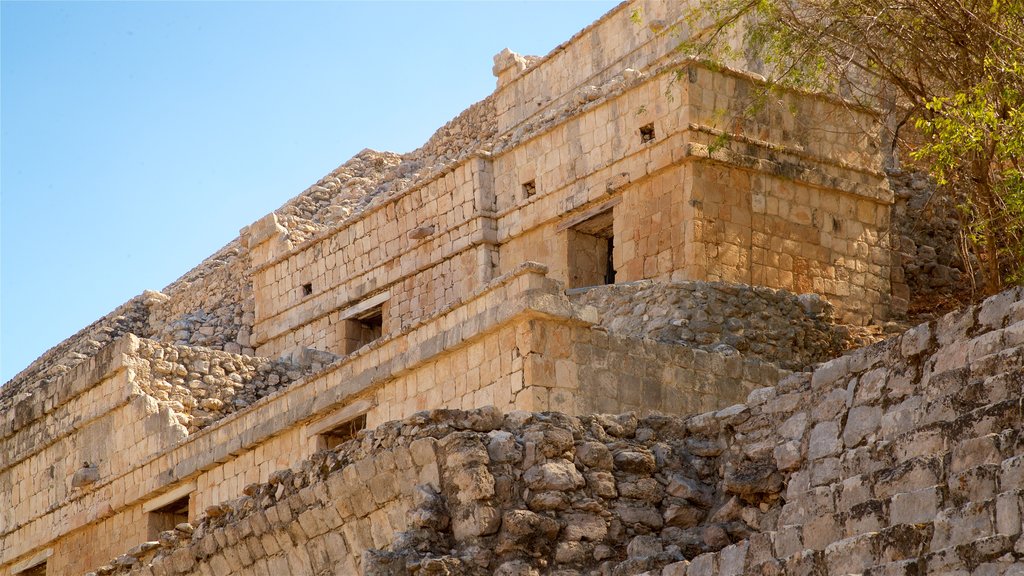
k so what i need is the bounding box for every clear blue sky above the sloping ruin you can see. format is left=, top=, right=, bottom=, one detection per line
left=0, top=0, right=616, bottom=383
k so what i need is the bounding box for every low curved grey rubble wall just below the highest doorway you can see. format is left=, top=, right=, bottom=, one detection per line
left=571, top=281, right=846, bottom=370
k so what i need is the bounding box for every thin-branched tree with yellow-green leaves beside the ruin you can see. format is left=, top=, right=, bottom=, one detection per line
left=680, top=0, right=1024, bottom=293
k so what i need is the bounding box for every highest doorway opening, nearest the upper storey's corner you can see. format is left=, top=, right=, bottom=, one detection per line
left=566, top=210, right=615, bottom=288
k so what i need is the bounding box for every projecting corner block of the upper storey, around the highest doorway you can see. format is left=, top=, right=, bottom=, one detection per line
left=493, top=61, right=892, bottom=324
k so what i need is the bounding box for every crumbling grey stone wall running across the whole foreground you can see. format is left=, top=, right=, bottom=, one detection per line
left=92, top=288, right=1024, bottom=576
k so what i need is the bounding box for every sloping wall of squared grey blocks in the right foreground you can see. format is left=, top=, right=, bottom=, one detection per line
left=663, top=288, right=1024, bottom=576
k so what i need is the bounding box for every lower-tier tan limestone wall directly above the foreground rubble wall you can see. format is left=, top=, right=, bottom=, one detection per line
left=0, top=263, right=798, bottom=573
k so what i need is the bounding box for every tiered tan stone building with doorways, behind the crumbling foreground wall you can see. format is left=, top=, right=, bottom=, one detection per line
left=0, top=1, right=921, bottom=575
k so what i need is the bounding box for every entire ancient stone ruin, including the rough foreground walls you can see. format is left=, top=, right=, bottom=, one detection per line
left=0, top=0, right=1024, bottom=576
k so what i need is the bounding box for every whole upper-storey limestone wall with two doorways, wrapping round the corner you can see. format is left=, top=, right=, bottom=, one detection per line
left=244, top=43, right=892, bottom=362
